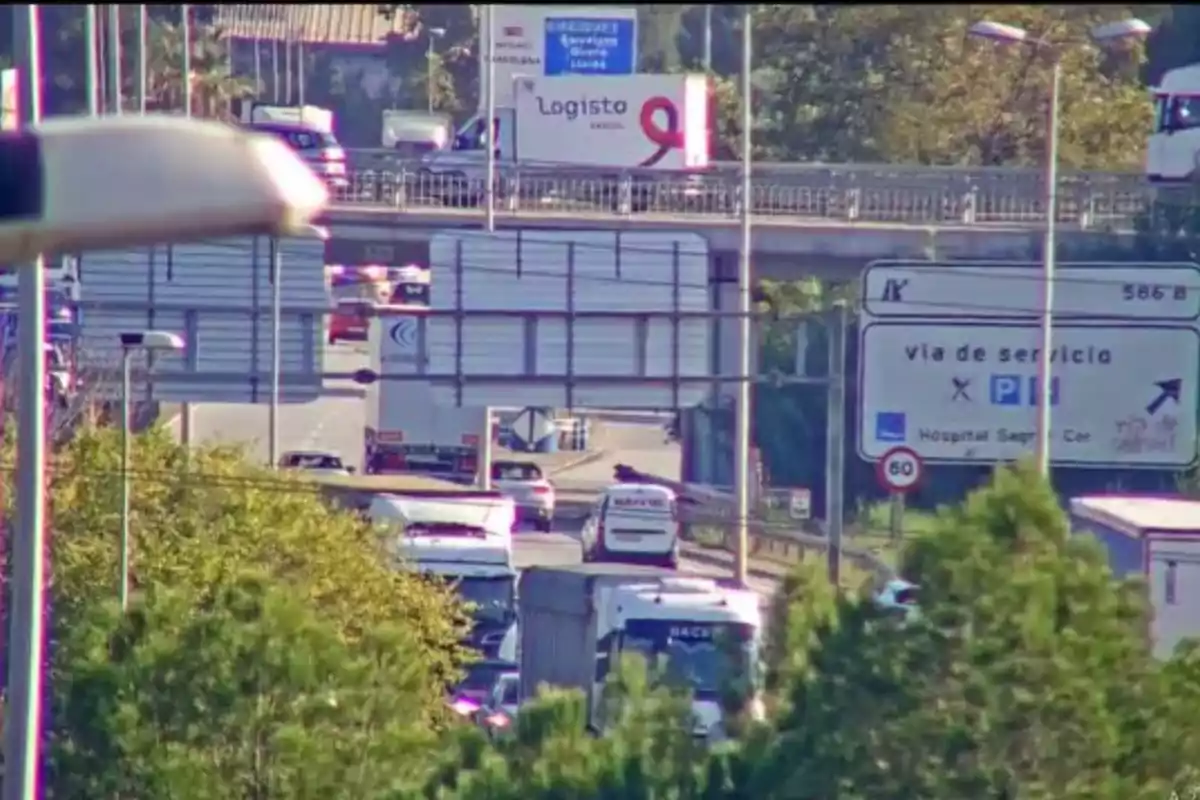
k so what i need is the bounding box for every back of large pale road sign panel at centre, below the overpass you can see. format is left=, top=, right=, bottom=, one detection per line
left=420, top=229, right=714, bottom=409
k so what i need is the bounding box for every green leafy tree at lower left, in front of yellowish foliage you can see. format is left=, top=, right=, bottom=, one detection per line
left=49, top=576, right=436, bottom=800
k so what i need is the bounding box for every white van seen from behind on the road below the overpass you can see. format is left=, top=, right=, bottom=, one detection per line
left=580, top=483, right=679, bottom=569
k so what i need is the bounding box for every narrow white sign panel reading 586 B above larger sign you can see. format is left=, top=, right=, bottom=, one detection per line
left=862, top=261, right=1200, bottom=323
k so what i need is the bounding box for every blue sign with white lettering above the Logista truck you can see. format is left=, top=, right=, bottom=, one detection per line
left=544, top=17, right=637, bottom=76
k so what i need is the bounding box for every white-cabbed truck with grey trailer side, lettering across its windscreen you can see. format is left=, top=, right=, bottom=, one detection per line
left=518, top=564, right=762, bottom=740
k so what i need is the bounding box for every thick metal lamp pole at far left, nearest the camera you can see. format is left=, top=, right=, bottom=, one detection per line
left=4, top=5, right=46, bottom=800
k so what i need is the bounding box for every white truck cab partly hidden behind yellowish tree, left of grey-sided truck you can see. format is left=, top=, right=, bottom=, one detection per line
left=367, top=492, right=517, bottom=658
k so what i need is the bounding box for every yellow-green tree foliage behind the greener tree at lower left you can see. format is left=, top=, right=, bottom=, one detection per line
left=25, top=428, right=466, bottom=705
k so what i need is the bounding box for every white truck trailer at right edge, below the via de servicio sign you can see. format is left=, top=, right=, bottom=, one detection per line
left=1070, top=494, right=1200, bottom=658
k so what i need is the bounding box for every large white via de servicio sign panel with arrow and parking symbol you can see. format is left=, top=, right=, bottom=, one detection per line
left=858, top=323, right=1200, bottom=468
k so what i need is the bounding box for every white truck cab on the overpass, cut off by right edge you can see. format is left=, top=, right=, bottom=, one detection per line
left=1146, top=64, right=1200, bottom=186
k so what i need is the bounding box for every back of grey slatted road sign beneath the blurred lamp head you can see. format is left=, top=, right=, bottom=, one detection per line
left=79, top=236, right=330, bottom=403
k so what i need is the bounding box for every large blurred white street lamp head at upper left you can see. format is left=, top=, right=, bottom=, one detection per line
left=0, top=116, right=329, bottom=263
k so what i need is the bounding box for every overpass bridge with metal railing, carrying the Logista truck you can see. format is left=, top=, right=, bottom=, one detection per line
left=326, top=159, right=1152, bottom=282
